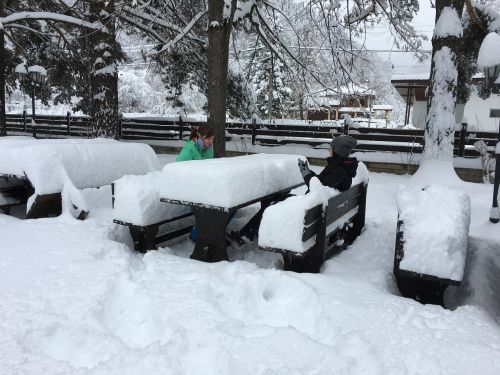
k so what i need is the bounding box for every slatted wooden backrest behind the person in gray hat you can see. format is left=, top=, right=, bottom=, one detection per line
left=302, top=183, right=367, bottom=258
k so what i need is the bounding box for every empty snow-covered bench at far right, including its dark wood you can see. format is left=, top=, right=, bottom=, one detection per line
left=394, top=185, right=470, bottom=306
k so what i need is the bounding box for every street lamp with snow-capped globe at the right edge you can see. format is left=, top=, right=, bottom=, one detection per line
left=477, top=33, right=500, bottom=223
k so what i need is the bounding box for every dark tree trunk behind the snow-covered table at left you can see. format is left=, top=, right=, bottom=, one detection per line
left=90, top=0, right=120, bottom=138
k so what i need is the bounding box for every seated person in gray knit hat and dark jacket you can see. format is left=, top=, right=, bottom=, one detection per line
left=299, top=135, right=358, bottom=191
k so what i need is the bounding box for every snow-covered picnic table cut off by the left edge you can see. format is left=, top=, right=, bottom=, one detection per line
left=0, top=137, right=159, bottom=218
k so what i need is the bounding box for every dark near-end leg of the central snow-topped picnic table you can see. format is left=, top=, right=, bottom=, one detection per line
left=191, top=207, right=230, bottom=262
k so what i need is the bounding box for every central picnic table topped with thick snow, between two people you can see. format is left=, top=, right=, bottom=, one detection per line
left=160, top=154, right=305, bottom=262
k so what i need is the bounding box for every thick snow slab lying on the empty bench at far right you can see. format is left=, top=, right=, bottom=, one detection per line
left=397, top=185, right=471, bottom=281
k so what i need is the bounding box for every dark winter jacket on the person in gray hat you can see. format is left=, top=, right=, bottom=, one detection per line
left=304, top=154, right=358, bottom=191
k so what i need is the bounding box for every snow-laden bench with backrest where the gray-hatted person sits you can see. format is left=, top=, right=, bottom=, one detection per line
left=259, top=163, right=368, bottom=272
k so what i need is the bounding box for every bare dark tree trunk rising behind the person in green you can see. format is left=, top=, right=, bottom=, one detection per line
left=208, top=0, right=236, bottom=157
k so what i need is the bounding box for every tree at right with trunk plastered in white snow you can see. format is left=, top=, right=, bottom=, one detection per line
left=424, top=0, right=500, bottom=170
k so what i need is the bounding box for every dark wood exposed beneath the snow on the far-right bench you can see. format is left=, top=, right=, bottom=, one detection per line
left=393, top=218, right=461, bottom=307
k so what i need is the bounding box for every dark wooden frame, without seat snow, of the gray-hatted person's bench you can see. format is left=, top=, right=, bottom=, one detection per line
left=260, top=183, right=368, bottom=273
